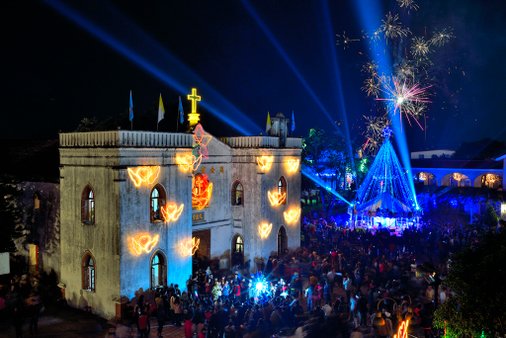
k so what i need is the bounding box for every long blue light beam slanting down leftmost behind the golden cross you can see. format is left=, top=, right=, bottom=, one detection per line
left=45, top=0, right=262, bottom=135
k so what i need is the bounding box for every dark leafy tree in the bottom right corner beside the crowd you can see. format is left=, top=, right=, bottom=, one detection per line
left=435, top=231, right=506, bottom=337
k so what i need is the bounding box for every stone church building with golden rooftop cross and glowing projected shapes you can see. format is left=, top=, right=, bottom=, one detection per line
left=59, top=92, right=301, bottom=318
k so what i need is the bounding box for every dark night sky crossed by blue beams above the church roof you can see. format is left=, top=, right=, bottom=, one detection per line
left=0, top=0, right=506, bottom=150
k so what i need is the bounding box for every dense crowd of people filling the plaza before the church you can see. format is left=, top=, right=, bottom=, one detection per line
left=0, top=210, right=490, bottom=338
